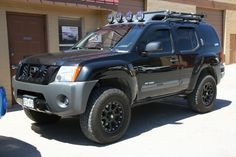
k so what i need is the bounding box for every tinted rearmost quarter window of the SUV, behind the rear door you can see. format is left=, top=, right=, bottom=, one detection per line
left=199, top=25, right=220, bottom=48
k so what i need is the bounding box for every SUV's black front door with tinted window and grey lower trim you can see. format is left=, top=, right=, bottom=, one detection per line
left=135, top=26, right=180, bottom=99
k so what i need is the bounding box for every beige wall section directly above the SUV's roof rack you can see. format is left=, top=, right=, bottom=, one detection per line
left=146, top=0, right=196, bottom=13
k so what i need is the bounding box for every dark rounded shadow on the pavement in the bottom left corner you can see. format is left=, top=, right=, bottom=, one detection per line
left=0, top=136, right=41, bottom=157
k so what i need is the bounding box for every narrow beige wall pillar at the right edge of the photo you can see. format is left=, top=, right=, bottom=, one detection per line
left=224, top=10, right=236, bottom=64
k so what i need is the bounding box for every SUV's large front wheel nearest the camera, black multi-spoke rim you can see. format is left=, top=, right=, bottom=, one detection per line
left=80, top=88, right=131, bottom=144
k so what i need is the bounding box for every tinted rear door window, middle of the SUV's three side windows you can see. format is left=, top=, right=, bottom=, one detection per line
left=176, top=28, right=198, bottom=51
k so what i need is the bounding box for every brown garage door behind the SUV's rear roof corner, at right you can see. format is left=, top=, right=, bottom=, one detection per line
left=197, top=8, right=223, bottom=43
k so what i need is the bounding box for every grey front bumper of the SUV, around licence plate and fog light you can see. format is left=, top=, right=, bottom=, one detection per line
left=12, top=77, right=97, bottom=116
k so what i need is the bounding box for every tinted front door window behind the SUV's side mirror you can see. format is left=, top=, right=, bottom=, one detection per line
left=138, top=29, right=172, bottom=53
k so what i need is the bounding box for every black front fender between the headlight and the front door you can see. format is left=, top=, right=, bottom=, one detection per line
left=77, top=60, right=138, bottom=103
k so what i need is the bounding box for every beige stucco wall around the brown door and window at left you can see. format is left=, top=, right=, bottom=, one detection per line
left=0, top=0, right=109, bottom=104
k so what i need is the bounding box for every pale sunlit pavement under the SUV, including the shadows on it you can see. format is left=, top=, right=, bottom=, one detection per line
left=0, top=65, right=236, bottom=157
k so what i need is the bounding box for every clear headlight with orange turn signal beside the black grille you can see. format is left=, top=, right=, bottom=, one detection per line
left=55, top=66, right=81, bottom=82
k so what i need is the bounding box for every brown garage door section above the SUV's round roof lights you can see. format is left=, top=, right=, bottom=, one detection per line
left=118, top=0, right=144, bottom=13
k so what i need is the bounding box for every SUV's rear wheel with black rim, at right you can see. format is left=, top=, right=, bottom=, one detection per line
left=188, top=75, right=217, bottom=113
